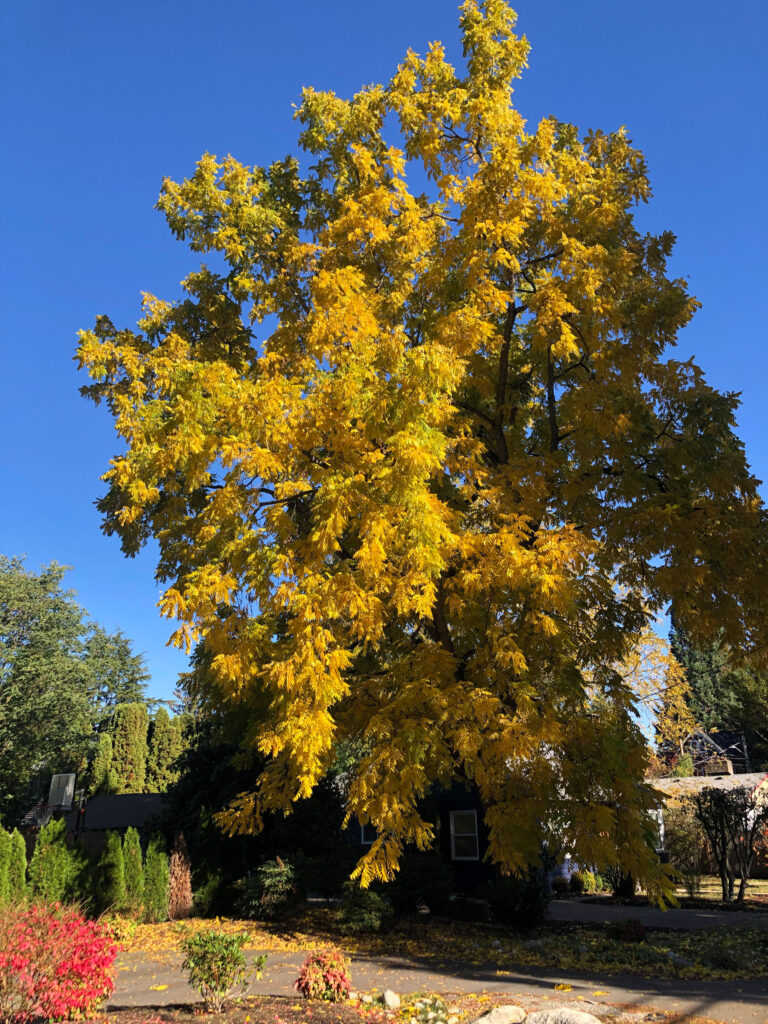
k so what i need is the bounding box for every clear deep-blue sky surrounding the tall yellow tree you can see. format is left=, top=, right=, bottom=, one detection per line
left=0, top=0, right=768, bottom=696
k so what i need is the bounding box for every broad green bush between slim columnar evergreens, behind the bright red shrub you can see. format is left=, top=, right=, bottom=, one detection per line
left=27, top=818, right=89, bottom=903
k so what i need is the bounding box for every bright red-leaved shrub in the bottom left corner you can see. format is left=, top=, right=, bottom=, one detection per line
left=0, top=903, right=118, bottom=1024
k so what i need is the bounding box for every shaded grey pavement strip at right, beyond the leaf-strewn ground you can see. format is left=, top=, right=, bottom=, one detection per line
left=549, top=897, right=768, bottom=931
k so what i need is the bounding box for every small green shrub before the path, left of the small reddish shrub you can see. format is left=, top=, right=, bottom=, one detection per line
left=180, top=931, right=266, bottom=1014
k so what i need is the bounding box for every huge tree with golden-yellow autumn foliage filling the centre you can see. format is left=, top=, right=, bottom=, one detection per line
left=79, top=0, right=765, bottom=897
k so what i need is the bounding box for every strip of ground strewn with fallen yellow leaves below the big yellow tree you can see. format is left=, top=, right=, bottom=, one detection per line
left=117, top=908, right=768, bottom=979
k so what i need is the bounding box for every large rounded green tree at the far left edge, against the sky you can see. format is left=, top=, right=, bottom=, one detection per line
left=0, top=555, right=91, bottom=819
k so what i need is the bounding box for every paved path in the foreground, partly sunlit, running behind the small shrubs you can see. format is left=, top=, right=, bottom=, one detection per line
left=110, top=952, right=768, bottom=1024
